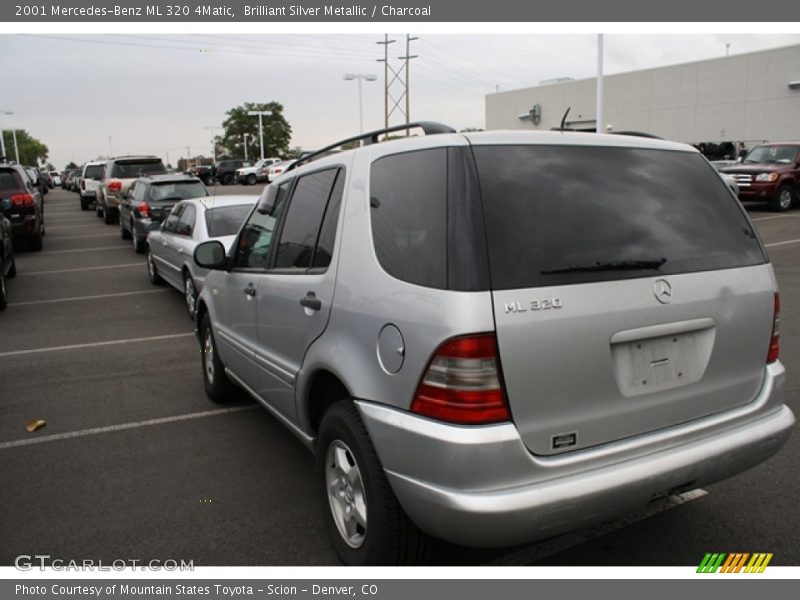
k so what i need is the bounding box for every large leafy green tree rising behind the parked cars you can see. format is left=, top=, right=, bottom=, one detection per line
left=214, top=102, right=292, bottom=158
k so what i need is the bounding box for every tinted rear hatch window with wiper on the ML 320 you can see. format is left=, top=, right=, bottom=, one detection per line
left=474, top=146, right=765, bottom=289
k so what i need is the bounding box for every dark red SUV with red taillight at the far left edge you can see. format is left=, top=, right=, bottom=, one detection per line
left=0, top=163, right=45, bottom=250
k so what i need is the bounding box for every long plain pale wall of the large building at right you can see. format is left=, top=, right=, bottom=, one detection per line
left=486, top=45, right=800, bottom=144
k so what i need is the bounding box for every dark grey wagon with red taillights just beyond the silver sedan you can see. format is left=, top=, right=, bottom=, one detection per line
left=119, top=175, right=208, bottom=253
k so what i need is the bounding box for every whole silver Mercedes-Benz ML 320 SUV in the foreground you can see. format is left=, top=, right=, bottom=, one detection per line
left=189, top=123, right=794, bottom=564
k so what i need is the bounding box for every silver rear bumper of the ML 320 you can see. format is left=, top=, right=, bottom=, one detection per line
left=357, top=363, right=795, bottom=547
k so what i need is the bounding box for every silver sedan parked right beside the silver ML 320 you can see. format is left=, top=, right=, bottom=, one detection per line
left=145, top=196, right=258, bottom=318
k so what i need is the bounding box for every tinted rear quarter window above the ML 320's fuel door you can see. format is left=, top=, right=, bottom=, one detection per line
left=370, top=148, right=447, bottom=288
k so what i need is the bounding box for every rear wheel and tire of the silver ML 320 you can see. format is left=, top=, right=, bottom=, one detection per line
left=317, top=400, right=431, bottom=566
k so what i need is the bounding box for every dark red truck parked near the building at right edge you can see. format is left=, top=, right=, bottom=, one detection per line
left=721, top=142, right=800, bottom=211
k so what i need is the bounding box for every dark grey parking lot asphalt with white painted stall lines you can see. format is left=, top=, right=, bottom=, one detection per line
left=0, top=186, right=800, bottom=566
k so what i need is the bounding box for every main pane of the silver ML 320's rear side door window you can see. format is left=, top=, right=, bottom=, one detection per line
left=275, top=169, right=337, bottom=269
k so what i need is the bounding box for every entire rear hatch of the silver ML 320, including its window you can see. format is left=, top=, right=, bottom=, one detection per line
left=474, top=144, right=775, bottom=455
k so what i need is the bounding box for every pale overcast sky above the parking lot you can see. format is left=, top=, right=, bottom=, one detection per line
left=0, top=32, right=800, bottom=169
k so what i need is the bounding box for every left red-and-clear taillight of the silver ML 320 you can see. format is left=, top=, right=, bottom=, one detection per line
left=411, top=334, right=511, bottom=425
